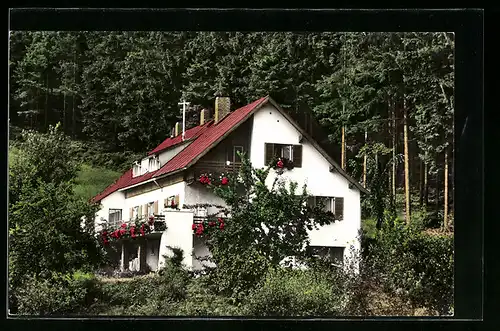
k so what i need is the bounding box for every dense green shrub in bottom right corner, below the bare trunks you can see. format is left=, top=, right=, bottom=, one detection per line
left=366, top=223, right=453, bottom=314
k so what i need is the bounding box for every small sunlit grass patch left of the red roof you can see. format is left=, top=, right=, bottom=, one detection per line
left=74, top=164, right=121, bottom=199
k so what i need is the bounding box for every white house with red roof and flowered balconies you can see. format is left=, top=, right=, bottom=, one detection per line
left=94, top=97, right=366, bottom=270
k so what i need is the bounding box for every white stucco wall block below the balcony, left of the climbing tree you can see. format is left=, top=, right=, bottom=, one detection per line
left=158, top=210, right=193, bottom=268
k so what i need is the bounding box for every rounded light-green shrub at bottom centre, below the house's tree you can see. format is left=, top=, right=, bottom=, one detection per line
left=245, top=268, right=345, bottom=316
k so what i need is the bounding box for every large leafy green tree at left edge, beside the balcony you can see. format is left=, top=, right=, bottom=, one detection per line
left=9, top=126, right=102, bottom=286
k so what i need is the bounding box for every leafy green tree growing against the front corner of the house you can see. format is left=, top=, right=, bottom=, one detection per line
left=188, top=156, right=334, bottom=295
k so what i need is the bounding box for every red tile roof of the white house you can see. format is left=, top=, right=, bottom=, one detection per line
left=92, top=97, right=268, bottom=202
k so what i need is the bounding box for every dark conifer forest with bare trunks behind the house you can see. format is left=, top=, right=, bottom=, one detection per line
left=9, top=31, right=454, bottom=311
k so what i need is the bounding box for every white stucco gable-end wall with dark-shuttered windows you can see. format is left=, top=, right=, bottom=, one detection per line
left=250, top=105, right=361, bottom=257
